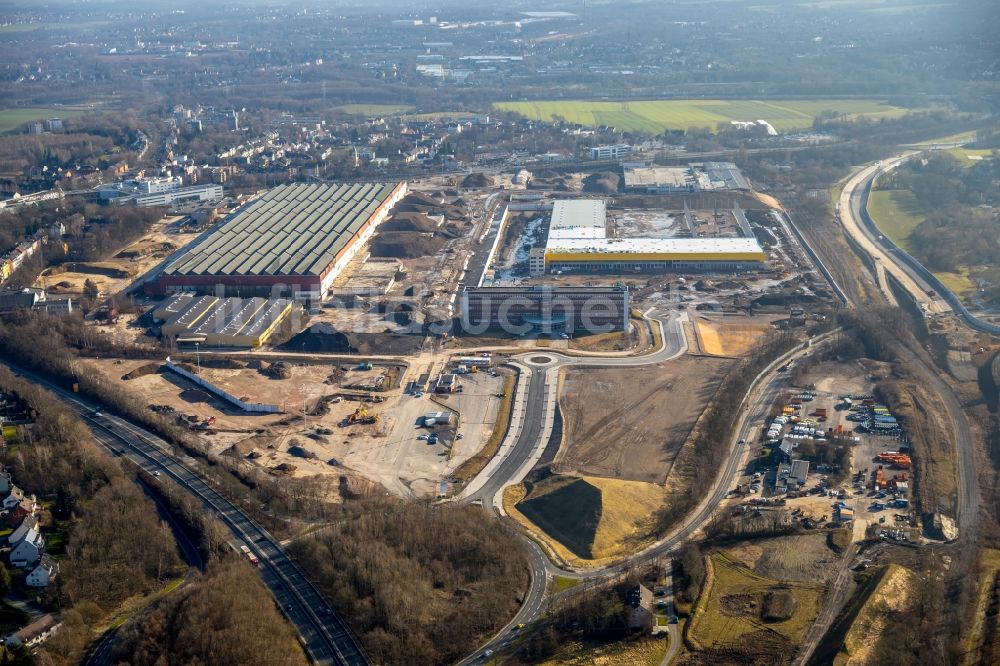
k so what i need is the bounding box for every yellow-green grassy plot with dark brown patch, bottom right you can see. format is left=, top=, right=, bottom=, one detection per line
left=688, top=551, right=823, bottom=654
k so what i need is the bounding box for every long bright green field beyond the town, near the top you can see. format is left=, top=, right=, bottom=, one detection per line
left=494, top=99, right=907, bottom=134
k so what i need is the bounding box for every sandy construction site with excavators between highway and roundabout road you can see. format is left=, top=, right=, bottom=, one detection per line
left=88, top=354, right=504, bottom=497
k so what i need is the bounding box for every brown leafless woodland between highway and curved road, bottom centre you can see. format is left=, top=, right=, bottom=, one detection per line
left=288, top=497, right=528, bottom=664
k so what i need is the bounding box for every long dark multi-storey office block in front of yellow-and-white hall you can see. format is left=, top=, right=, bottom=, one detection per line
left=462, top=286, right=630, bottom=334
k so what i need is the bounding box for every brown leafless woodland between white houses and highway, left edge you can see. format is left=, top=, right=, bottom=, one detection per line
left=0, top=367, right=183, bottom=664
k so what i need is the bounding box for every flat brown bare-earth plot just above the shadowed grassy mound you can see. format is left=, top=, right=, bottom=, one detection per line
left=555, top=356, right=731, bottom=483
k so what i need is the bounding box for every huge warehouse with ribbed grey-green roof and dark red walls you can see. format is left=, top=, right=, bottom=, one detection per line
left=150, top=183, right=406, bottom=298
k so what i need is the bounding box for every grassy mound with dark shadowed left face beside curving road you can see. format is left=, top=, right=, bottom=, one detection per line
left=514, top=475, right=664, bottom=563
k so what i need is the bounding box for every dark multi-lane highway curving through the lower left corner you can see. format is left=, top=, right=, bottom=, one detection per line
left=1, top=367, right=371, bottom=666
